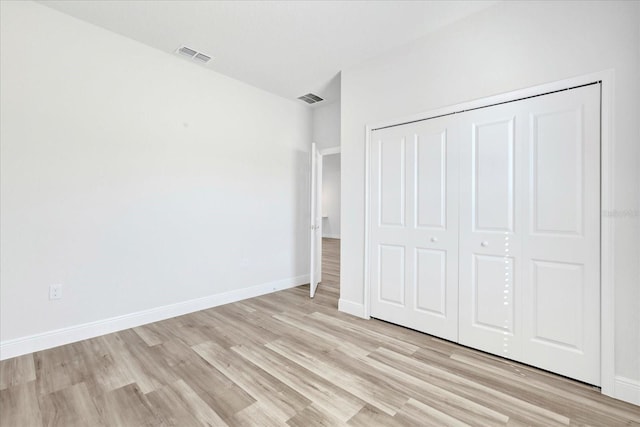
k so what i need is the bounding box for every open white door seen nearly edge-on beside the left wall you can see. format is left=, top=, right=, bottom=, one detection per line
left=309, top=142, right=322, bottom=298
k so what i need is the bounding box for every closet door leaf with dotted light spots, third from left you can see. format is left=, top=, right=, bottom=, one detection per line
left=459, top=103, right=524, bottom=360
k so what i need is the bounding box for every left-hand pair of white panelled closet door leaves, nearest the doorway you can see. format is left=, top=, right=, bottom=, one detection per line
left=370, top=117, right=458, bottom=341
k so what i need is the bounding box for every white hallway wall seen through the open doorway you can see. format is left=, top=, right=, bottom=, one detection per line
left=322, top=153, right=340, bottom=239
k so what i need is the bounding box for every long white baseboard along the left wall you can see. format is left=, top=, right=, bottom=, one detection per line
left=0, top=275, right=309, bottom=360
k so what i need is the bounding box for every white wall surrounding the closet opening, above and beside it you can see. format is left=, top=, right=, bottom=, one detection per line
left=340, top=1, right=640, bottom=398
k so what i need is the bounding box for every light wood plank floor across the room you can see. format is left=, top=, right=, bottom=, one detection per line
left=0, top=239, right=640, bottom=427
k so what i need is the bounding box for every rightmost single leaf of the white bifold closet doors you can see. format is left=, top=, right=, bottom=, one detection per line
left=522, top=85, right=600, bottom=385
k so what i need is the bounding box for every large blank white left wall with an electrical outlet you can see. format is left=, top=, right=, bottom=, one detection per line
left=0, top=1, right=312, bottom=356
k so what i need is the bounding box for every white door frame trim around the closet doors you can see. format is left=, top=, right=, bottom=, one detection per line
left=363, top=69, right=615, bottom=397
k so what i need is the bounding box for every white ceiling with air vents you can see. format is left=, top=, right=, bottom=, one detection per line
left=41, top=0, right=497, bottom=105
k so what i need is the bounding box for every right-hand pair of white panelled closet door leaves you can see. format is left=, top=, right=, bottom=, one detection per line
left=460, top=85, right=600, bottom=385
